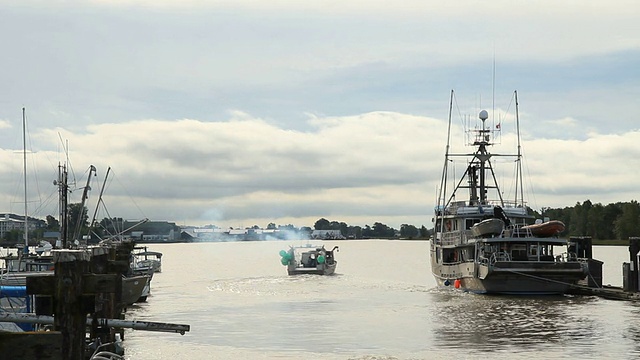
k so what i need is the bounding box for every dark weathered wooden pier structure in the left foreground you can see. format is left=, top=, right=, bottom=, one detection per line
left=0, top=241, right=190, bottom=360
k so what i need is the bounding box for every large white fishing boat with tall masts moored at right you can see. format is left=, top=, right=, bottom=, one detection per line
left=430, top=91, right=587, bottom=295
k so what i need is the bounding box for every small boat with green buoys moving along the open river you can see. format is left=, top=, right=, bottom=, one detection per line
left=280, top=244, right=339, bottom=275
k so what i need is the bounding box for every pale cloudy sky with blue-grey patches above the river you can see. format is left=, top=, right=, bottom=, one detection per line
left=0, top=0, right=640, bottom=228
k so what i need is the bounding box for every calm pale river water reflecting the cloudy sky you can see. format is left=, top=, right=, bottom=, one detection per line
left=124, top=240, right=640, bottom=360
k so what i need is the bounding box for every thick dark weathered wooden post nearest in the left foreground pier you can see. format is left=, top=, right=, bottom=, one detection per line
left=53, top=250, right=93, bottom=360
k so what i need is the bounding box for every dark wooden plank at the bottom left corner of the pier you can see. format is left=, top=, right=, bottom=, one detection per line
left=0, top=331, right=62, bottom=360
